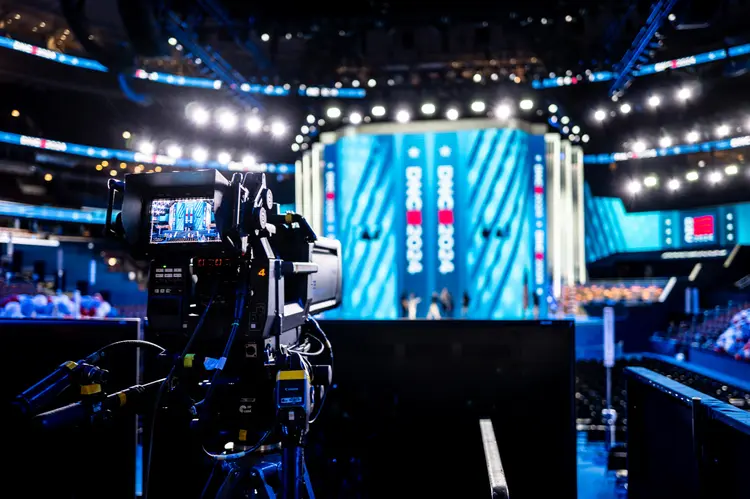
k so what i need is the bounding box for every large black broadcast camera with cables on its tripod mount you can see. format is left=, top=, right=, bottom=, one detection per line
left=17, top=170, right=341, bottom=498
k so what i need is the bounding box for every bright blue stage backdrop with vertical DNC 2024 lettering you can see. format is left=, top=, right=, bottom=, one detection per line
left=322, top=128, right=546, bottom=319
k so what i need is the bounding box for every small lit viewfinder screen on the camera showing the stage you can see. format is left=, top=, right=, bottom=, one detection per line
left=149, top=198, right=221, bottom=244
